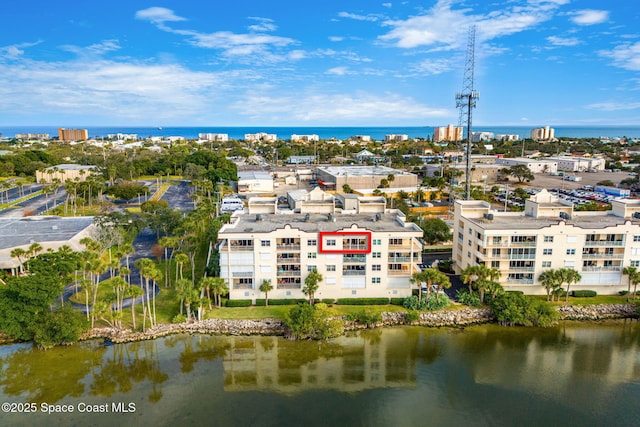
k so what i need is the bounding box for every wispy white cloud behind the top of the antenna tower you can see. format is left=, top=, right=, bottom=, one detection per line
left=379, top=0, right=567, bottom=50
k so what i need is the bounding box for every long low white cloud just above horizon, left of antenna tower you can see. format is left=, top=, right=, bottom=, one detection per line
left=232, top=92, right=452, bottom=125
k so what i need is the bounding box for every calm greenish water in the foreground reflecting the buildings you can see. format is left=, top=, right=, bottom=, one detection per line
left=0, top=320, right=640, bottom=426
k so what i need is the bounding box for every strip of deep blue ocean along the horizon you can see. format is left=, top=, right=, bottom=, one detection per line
left=0, top=125, right=640, bottom=140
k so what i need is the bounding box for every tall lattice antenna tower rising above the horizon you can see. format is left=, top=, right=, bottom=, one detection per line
left=456, top=25, right=480, bottom=200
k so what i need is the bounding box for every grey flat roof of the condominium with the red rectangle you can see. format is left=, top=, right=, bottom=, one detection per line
left=218, top=213, right=422, bottom=238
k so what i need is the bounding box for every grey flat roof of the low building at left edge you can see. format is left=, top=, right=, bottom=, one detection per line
left=0, top=216, right=93, bottom=250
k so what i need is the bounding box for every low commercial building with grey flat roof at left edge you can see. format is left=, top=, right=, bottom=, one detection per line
left=0, top=216, right=94, bottom=275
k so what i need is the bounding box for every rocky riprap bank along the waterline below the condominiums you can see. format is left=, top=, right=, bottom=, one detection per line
left=81, top=304, right=638, bottom=343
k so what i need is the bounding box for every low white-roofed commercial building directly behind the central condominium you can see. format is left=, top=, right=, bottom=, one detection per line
left=316, top=166, right=418, bottom=189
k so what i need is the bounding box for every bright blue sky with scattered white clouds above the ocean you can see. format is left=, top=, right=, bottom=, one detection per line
left=0, top=0, right=640, bottom=127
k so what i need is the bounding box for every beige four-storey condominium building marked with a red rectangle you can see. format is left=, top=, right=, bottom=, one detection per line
left=218, top=189, right=422, bottom=301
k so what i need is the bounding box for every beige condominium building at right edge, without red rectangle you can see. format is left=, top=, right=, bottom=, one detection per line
left=453, top=190, right=640, bottom=294
